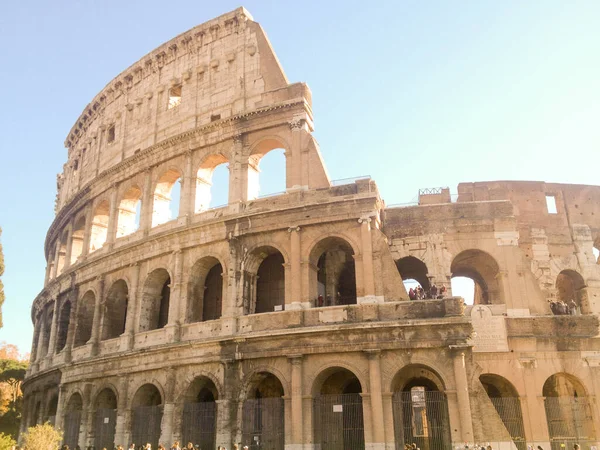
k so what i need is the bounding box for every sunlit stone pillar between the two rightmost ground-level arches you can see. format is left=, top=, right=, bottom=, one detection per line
left=519, top=358, right=550, bottom=448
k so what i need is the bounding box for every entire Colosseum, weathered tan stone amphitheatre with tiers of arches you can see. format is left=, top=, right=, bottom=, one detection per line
left=21, top=8, right=600, bottom=450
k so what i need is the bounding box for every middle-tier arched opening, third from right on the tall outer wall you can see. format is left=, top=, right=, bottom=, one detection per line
left=187, top=256, right=224, bottom=322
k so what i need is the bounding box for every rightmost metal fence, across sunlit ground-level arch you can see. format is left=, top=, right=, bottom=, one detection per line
left=544, top=397, right=595, bottom=450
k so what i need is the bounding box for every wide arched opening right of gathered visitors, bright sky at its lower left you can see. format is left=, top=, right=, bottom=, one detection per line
left=450, top=250, right=504, bottom=305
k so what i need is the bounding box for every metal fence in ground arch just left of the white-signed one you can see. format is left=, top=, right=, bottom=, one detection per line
left=242, top=397, right=285, bottom=450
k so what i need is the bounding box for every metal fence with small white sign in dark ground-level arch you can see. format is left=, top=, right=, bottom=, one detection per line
left=313, top=394, right=365, bottom=450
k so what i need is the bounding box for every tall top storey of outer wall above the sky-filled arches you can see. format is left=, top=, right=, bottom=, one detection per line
left=56, top=8, right=294, bottom=214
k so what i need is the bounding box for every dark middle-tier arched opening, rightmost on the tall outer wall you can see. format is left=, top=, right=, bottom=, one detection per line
left=309, top=237, right=357, bottom=306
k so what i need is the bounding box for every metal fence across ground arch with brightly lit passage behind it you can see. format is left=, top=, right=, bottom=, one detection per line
left=392, top=390, right=452, bottom=450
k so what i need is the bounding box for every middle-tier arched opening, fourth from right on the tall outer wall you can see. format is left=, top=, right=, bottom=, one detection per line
left=140, top=269, right=171, bottom=331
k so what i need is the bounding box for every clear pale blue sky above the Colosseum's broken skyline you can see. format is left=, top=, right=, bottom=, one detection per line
left=0, top=0, right=600, bottom=351
